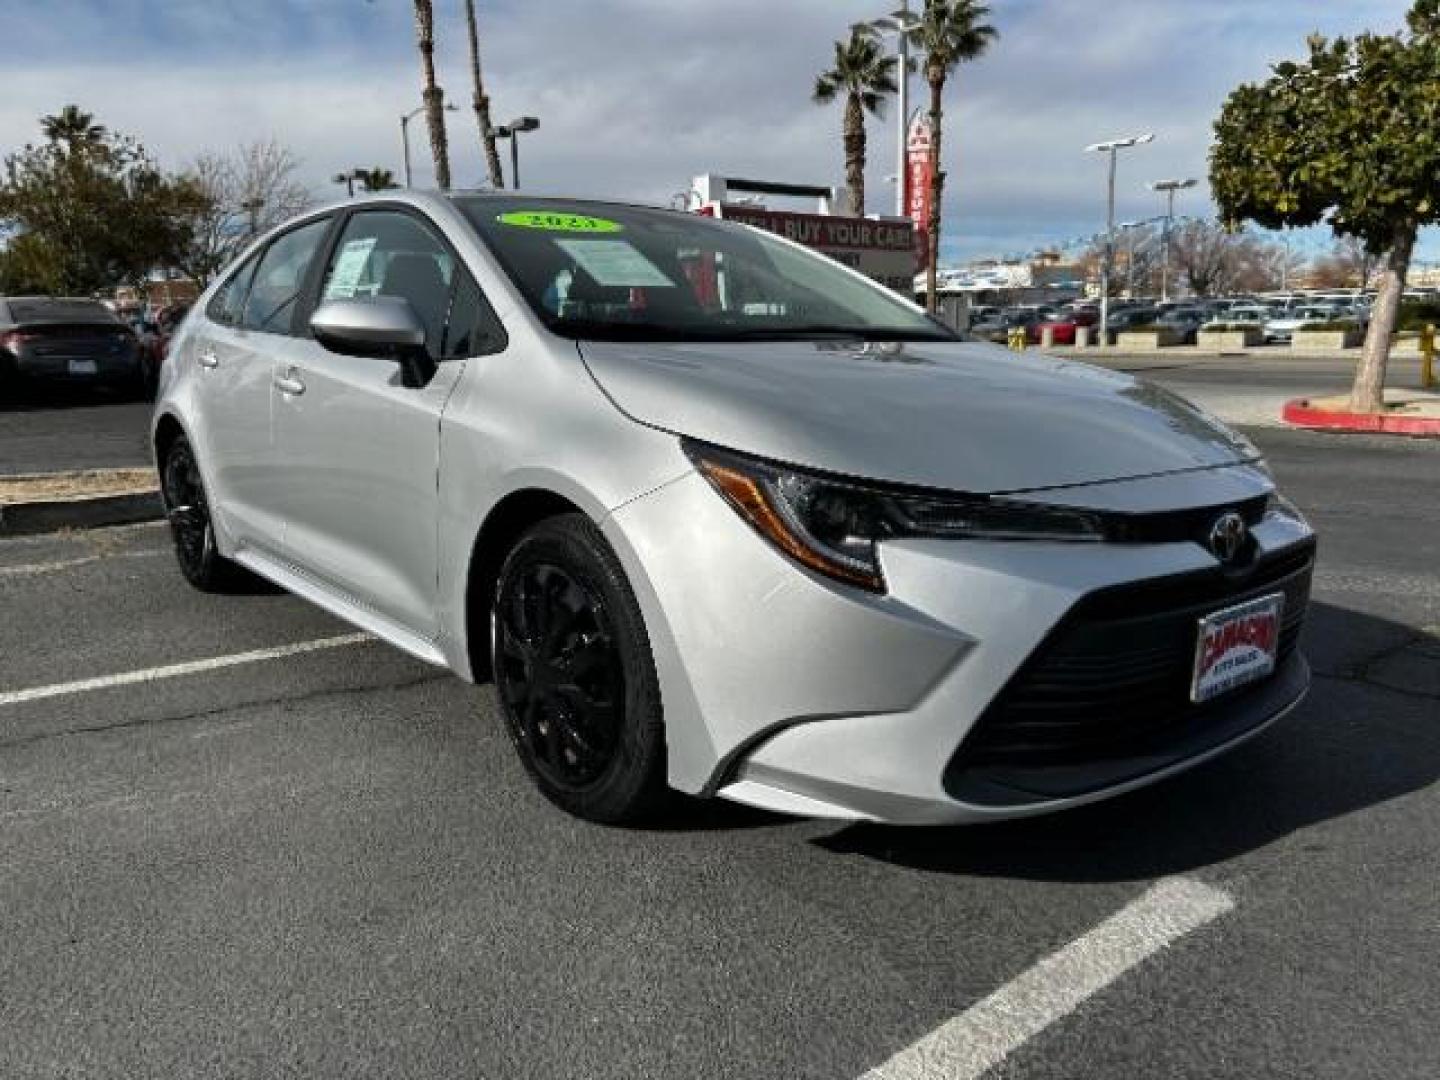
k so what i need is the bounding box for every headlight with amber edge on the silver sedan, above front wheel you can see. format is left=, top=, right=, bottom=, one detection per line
left=685, top=442, right=1103, bottom=592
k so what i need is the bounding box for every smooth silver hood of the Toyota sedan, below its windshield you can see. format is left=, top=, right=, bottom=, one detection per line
left=580, top=341, right=1259, bottom=492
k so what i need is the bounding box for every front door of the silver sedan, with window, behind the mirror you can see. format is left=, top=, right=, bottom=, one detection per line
left=275, top=207, right=503, bottom=641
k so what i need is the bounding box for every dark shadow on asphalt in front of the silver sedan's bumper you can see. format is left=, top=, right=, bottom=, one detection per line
left=815, top=603, right=1440, bottom=881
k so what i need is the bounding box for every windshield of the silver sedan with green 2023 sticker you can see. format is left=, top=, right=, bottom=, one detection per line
left=456, top=197, right=958, bottom=341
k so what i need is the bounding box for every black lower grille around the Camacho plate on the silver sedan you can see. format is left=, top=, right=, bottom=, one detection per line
left=946, top=543, right=1315, bottom=793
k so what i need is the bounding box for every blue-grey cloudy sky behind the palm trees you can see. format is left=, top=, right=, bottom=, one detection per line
left=0, top=0, right=1408, bottom=258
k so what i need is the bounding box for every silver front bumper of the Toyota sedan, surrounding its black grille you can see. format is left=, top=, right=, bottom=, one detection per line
left=606, top=468, right=1313, bottom=824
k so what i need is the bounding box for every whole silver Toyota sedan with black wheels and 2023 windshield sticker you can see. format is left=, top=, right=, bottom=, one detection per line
left=153, top=194, right=1315, bottom=824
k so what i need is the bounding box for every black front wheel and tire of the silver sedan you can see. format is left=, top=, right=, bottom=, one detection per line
left=491, top=514, right=665, bottom=824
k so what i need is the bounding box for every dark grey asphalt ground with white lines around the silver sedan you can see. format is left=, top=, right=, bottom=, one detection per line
left=0, top=420, right=1440, bottom=1080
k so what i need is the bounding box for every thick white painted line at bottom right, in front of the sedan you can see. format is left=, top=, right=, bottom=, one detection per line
left=861, top=877, right=1234, bottom=1080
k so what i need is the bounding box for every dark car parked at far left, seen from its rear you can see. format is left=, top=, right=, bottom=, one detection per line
left=0, top=297, right=144, bottom=393
